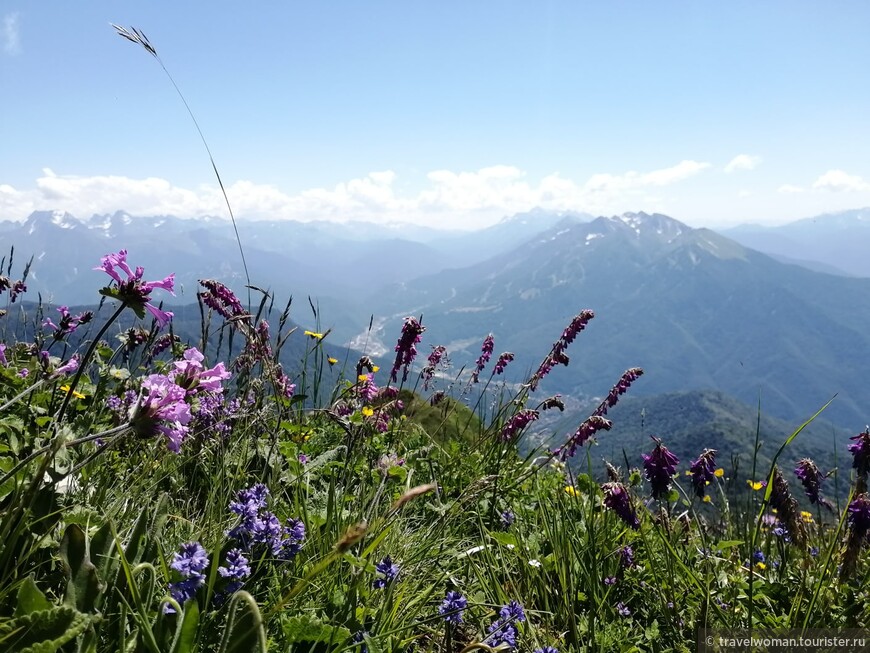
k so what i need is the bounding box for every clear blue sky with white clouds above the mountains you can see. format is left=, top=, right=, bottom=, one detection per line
left=0, top=0, right=870, bottom=228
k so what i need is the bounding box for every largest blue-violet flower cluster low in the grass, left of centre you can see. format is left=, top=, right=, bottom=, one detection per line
left=227, top=483, right=305, bottom=560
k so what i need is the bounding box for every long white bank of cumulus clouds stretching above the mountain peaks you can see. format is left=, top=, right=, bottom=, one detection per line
left=0, top=161, right=710, bottom=228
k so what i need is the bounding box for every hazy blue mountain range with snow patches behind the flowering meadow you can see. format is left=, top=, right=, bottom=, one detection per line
left=0, top=211, right=870, bottom=432
